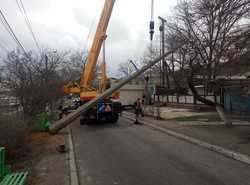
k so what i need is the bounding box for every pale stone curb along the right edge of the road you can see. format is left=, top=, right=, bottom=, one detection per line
left=123, top=114, right=250, bottom=164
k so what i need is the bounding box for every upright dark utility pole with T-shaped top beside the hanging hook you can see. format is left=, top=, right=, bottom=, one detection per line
left=158, top=16, right=170, bottom=88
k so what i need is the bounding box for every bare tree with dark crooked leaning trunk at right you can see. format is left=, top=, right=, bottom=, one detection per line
left=166, top=0, right=250, bottom=126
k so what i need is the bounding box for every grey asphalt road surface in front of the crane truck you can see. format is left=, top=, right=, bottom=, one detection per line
left=71, top=118, right=250, bottom=185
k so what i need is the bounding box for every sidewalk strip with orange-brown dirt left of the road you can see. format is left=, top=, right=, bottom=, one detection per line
left=32, top=128, right=71, bottom=185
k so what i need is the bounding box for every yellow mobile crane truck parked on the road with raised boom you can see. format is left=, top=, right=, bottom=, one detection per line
left=62, top=0, right=133, bottom=124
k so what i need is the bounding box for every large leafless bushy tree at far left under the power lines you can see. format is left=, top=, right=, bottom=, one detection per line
left=1, top=50, right=66, bottom=122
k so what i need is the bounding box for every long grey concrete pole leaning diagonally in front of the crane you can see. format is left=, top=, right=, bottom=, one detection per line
left=49, top=43, right=185, bottom=134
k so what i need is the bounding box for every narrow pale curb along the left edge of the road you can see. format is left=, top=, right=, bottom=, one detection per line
left=68, top=126, right=79, bottom=185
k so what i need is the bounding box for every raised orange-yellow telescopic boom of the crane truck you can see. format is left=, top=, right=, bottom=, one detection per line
left=80, top=0, right=115, bottom=91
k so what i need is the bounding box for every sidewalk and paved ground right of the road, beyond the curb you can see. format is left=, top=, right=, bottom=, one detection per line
left=123, top=107, right=250, bottom=161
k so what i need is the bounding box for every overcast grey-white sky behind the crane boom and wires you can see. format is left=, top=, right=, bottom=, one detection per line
left=0, top=0, right=175, bottom=76
